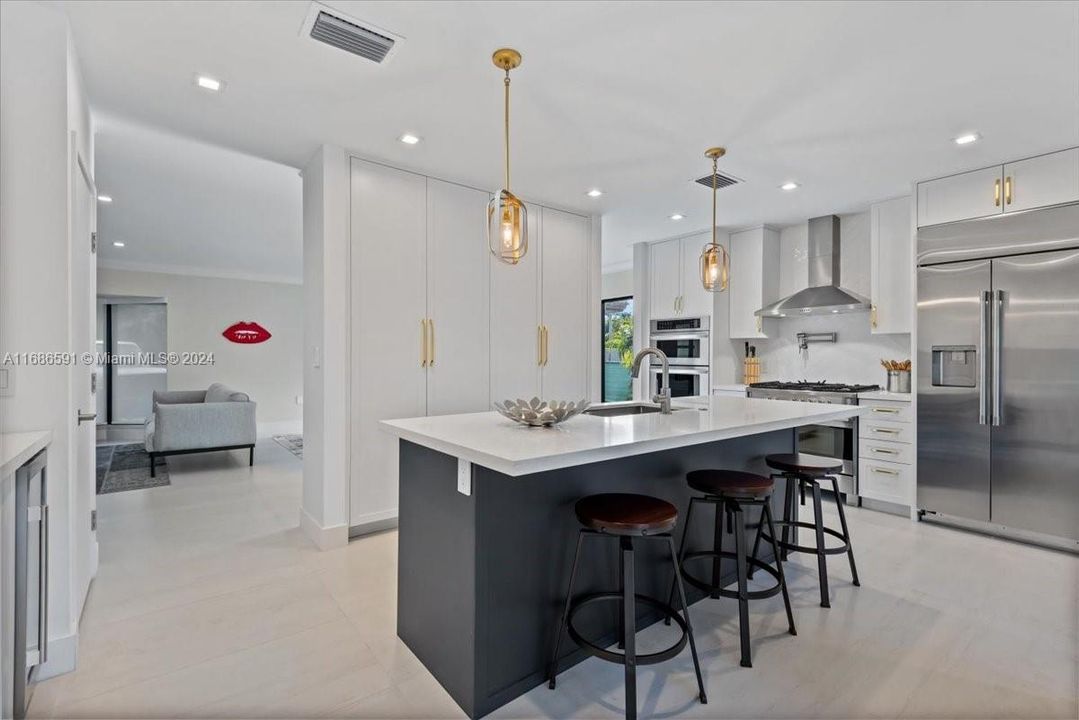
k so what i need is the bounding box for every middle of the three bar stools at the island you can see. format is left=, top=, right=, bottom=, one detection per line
left=671, top=470, right=797, bottom=667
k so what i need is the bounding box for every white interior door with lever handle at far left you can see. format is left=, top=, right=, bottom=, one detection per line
left=70, top=144, right=98, bottom=617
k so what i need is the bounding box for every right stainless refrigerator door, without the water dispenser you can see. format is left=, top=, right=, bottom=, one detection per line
left=992, top=249, right=1079, bottom=540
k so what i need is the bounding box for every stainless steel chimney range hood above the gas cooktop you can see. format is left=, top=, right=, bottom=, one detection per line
left=753, top=215, right=870, bottom=317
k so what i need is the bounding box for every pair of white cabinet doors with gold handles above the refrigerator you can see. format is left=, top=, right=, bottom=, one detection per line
left=917, top=148, right=1079, bottom=228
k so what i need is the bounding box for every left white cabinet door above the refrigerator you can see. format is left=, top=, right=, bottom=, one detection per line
left=918, top=165, right=1003, bottom=228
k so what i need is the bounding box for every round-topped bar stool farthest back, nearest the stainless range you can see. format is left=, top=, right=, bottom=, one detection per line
left=753, top=452, right=861, bottom=608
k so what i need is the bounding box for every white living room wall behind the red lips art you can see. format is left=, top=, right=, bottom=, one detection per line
left=97, top=267, right=303, bottom=436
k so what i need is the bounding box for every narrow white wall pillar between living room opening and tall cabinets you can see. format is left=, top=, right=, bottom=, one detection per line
left=300, top=146, right=350, bottom=549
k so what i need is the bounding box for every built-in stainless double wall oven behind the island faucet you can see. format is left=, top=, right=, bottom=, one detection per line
left=648, top=315, right=712, bottom=397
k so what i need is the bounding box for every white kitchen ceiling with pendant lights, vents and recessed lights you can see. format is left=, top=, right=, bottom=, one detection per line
left=64, top=0, right=1079, bottom=273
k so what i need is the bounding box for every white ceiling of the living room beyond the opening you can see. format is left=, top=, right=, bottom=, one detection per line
left=95, top=116, right=303, bottom=283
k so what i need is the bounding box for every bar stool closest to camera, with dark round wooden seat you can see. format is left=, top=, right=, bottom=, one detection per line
left=547, top=493, right=708, bottom=720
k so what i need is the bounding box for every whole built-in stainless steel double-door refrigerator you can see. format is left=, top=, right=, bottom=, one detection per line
left=917, top=199, right=1079, bottom=546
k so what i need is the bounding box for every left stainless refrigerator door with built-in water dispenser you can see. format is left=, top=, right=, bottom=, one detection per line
left=918, top=260, right=991, bottom=520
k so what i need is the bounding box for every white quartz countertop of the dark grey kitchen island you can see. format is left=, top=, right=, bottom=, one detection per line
left=380, top=396, right=864, bottom=476
